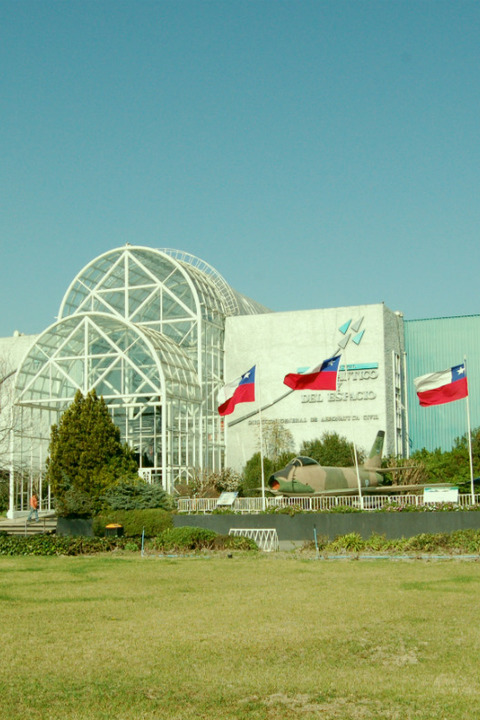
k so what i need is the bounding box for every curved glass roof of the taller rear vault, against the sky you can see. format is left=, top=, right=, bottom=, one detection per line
left=59, top=245, right=268, bottom=330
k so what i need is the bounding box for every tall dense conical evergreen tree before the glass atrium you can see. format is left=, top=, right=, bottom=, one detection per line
left=47, top=390, right=137, bottom=515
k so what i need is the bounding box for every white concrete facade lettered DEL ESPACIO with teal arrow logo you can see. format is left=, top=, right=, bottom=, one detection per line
left=225, top=304, right=406, bottom=470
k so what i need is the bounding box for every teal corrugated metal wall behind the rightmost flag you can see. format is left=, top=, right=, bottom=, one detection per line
left=405, top=315, right=480, bottom=452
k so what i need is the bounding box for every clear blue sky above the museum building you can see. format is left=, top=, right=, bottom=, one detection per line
left=0, top=0, right=480, bottom=336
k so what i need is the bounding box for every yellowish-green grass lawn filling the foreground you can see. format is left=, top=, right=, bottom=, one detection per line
left=0, top=553, right=480, bottom=720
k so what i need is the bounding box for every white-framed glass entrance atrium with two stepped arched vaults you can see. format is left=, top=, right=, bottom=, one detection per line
left=10, top=245, right=269, bottom=510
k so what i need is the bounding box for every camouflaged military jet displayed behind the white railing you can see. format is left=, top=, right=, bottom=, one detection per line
left=268, top=430, right=450, bottom=497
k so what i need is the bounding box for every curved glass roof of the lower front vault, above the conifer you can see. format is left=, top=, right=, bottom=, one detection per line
left=16, top=313, right=201, bottom=409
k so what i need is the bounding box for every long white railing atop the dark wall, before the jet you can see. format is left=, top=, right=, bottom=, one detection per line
left=177, top=493, right=480, bottom=514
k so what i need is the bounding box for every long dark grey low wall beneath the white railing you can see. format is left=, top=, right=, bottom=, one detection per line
left=173, top=511, right=480, bottom=543
